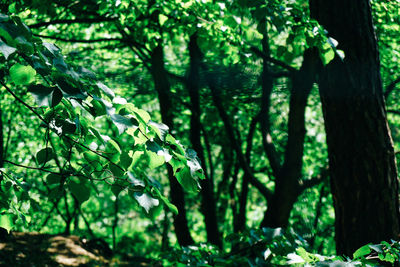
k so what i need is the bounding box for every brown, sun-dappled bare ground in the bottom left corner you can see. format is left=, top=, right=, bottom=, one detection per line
left=0, top=232, right=158, bottom=267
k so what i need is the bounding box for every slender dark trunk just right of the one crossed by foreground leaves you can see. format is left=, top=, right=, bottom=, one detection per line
left=187, top=34, right=222, bottom=248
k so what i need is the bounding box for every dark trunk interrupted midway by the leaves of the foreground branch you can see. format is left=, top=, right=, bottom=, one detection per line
left=151, top=45, right=194, bottom=246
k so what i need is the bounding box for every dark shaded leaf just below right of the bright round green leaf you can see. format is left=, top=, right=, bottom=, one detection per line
left=28, top=84, right=63, bottom=107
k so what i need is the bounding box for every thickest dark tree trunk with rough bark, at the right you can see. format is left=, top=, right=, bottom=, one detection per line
left=310, top=0, right=400, bottom=255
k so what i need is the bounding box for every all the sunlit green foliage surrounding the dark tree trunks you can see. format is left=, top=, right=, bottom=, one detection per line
left=0, top=0, right=400, bottom=266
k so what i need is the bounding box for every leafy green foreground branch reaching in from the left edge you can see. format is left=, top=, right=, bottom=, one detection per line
left=0, top=14, right=203, bottom=229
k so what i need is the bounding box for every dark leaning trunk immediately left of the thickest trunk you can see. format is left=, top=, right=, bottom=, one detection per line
left=261, top=49, right=318, bottom=227
